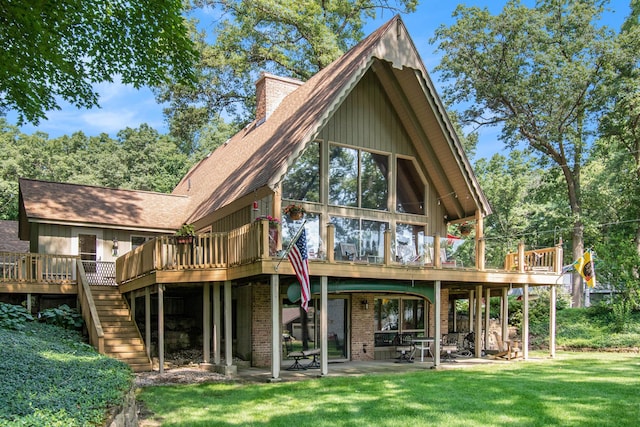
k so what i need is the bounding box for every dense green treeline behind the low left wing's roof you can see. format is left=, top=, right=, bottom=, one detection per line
left=0, top=119, right=193, bottom=220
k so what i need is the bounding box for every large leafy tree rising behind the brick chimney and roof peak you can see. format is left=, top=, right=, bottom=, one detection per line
left=158, top=0, right=417, bottom=154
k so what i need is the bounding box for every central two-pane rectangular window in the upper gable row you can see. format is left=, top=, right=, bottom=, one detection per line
left=329, top=145, right=389, bottom=210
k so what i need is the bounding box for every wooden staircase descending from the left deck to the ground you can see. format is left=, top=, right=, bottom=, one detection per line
left=91, top=286, right=151, bottom=372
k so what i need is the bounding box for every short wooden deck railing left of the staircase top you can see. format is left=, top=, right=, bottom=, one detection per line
left=0, top=252, right=79, bottom=283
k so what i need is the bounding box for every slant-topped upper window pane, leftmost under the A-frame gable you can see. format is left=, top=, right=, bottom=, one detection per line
left=282, top=143, right=320, bottom=202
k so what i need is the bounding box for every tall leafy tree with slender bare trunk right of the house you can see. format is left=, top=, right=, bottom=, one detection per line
left=435, top=0, right=615, bottom=306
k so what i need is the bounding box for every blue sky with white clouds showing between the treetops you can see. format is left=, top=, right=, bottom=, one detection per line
left=7, top=0, right=630, bottom=157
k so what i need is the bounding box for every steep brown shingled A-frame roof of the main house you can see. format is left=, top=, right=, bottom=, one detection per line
left=173, top=16, right=490, bottom=226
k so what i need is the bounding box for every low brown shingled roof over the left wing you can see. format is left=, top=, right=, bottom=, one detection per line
left=20, top=179, right=189, bottom=239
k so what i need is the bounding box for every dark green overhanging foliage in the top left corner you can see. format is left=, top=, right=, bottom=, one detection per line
left=0, top=0, right=196, bottom=124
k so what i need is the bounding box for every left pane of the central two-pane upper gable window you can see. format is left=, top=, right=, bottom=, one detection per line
left=329, top=146, right=358, bottom=206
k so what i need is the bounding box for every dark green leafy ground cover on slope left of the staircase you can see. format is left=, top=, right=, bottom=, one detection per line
left=0, top=322, right=133, bottom=427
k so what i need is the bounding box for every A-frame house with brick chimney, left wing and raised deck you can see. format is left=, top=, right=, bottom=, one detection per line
left=7, top=17, right=562, bottom=379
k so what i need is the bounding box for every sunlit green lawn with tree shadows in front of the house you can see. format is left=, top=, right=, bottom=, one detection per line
left=138, top=353, right=640, bottom=427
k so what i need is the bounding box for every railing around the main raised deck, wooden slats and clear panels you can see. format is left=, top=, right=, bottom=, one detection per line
left=116, top=221, right=562, bottom=283
